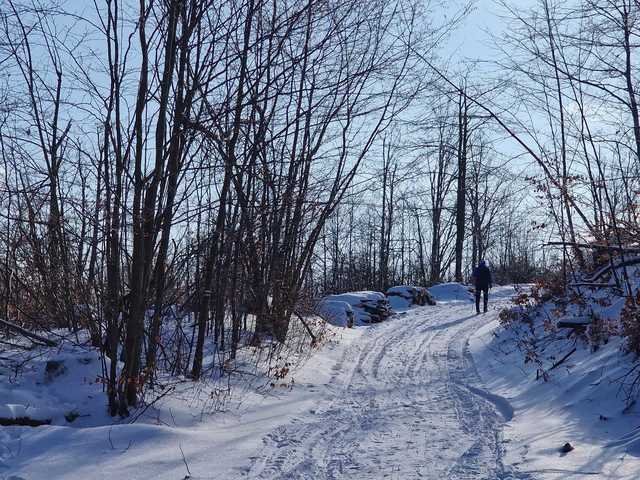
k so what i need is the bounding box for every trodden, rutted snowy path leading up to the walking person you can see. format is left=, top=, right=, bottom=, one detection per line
left=247, top=303, right=529, bottom=480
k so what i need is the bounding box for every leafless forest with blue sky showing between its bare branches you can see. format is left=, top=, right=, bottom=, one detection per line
left=0, top=0, right=640, bottom=464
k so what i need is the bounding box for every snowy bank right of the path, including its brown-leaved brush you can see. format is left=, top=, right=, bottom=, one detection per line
left=470, top=270, right=640, bottom=480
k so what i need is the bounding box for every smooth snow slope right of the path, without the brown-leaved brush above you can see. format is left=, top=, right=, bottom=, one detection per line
left=470, top=286, right=640, bottom=480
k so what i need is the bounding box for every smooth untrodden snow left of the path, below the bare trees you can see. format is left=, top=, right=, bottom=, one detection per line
left=0, top=326, right=364, bottom=480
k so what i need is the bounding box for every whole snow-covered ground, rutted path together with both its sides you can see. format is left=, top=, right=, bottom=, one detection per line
left=0, top=284, right=640, bottom=480
